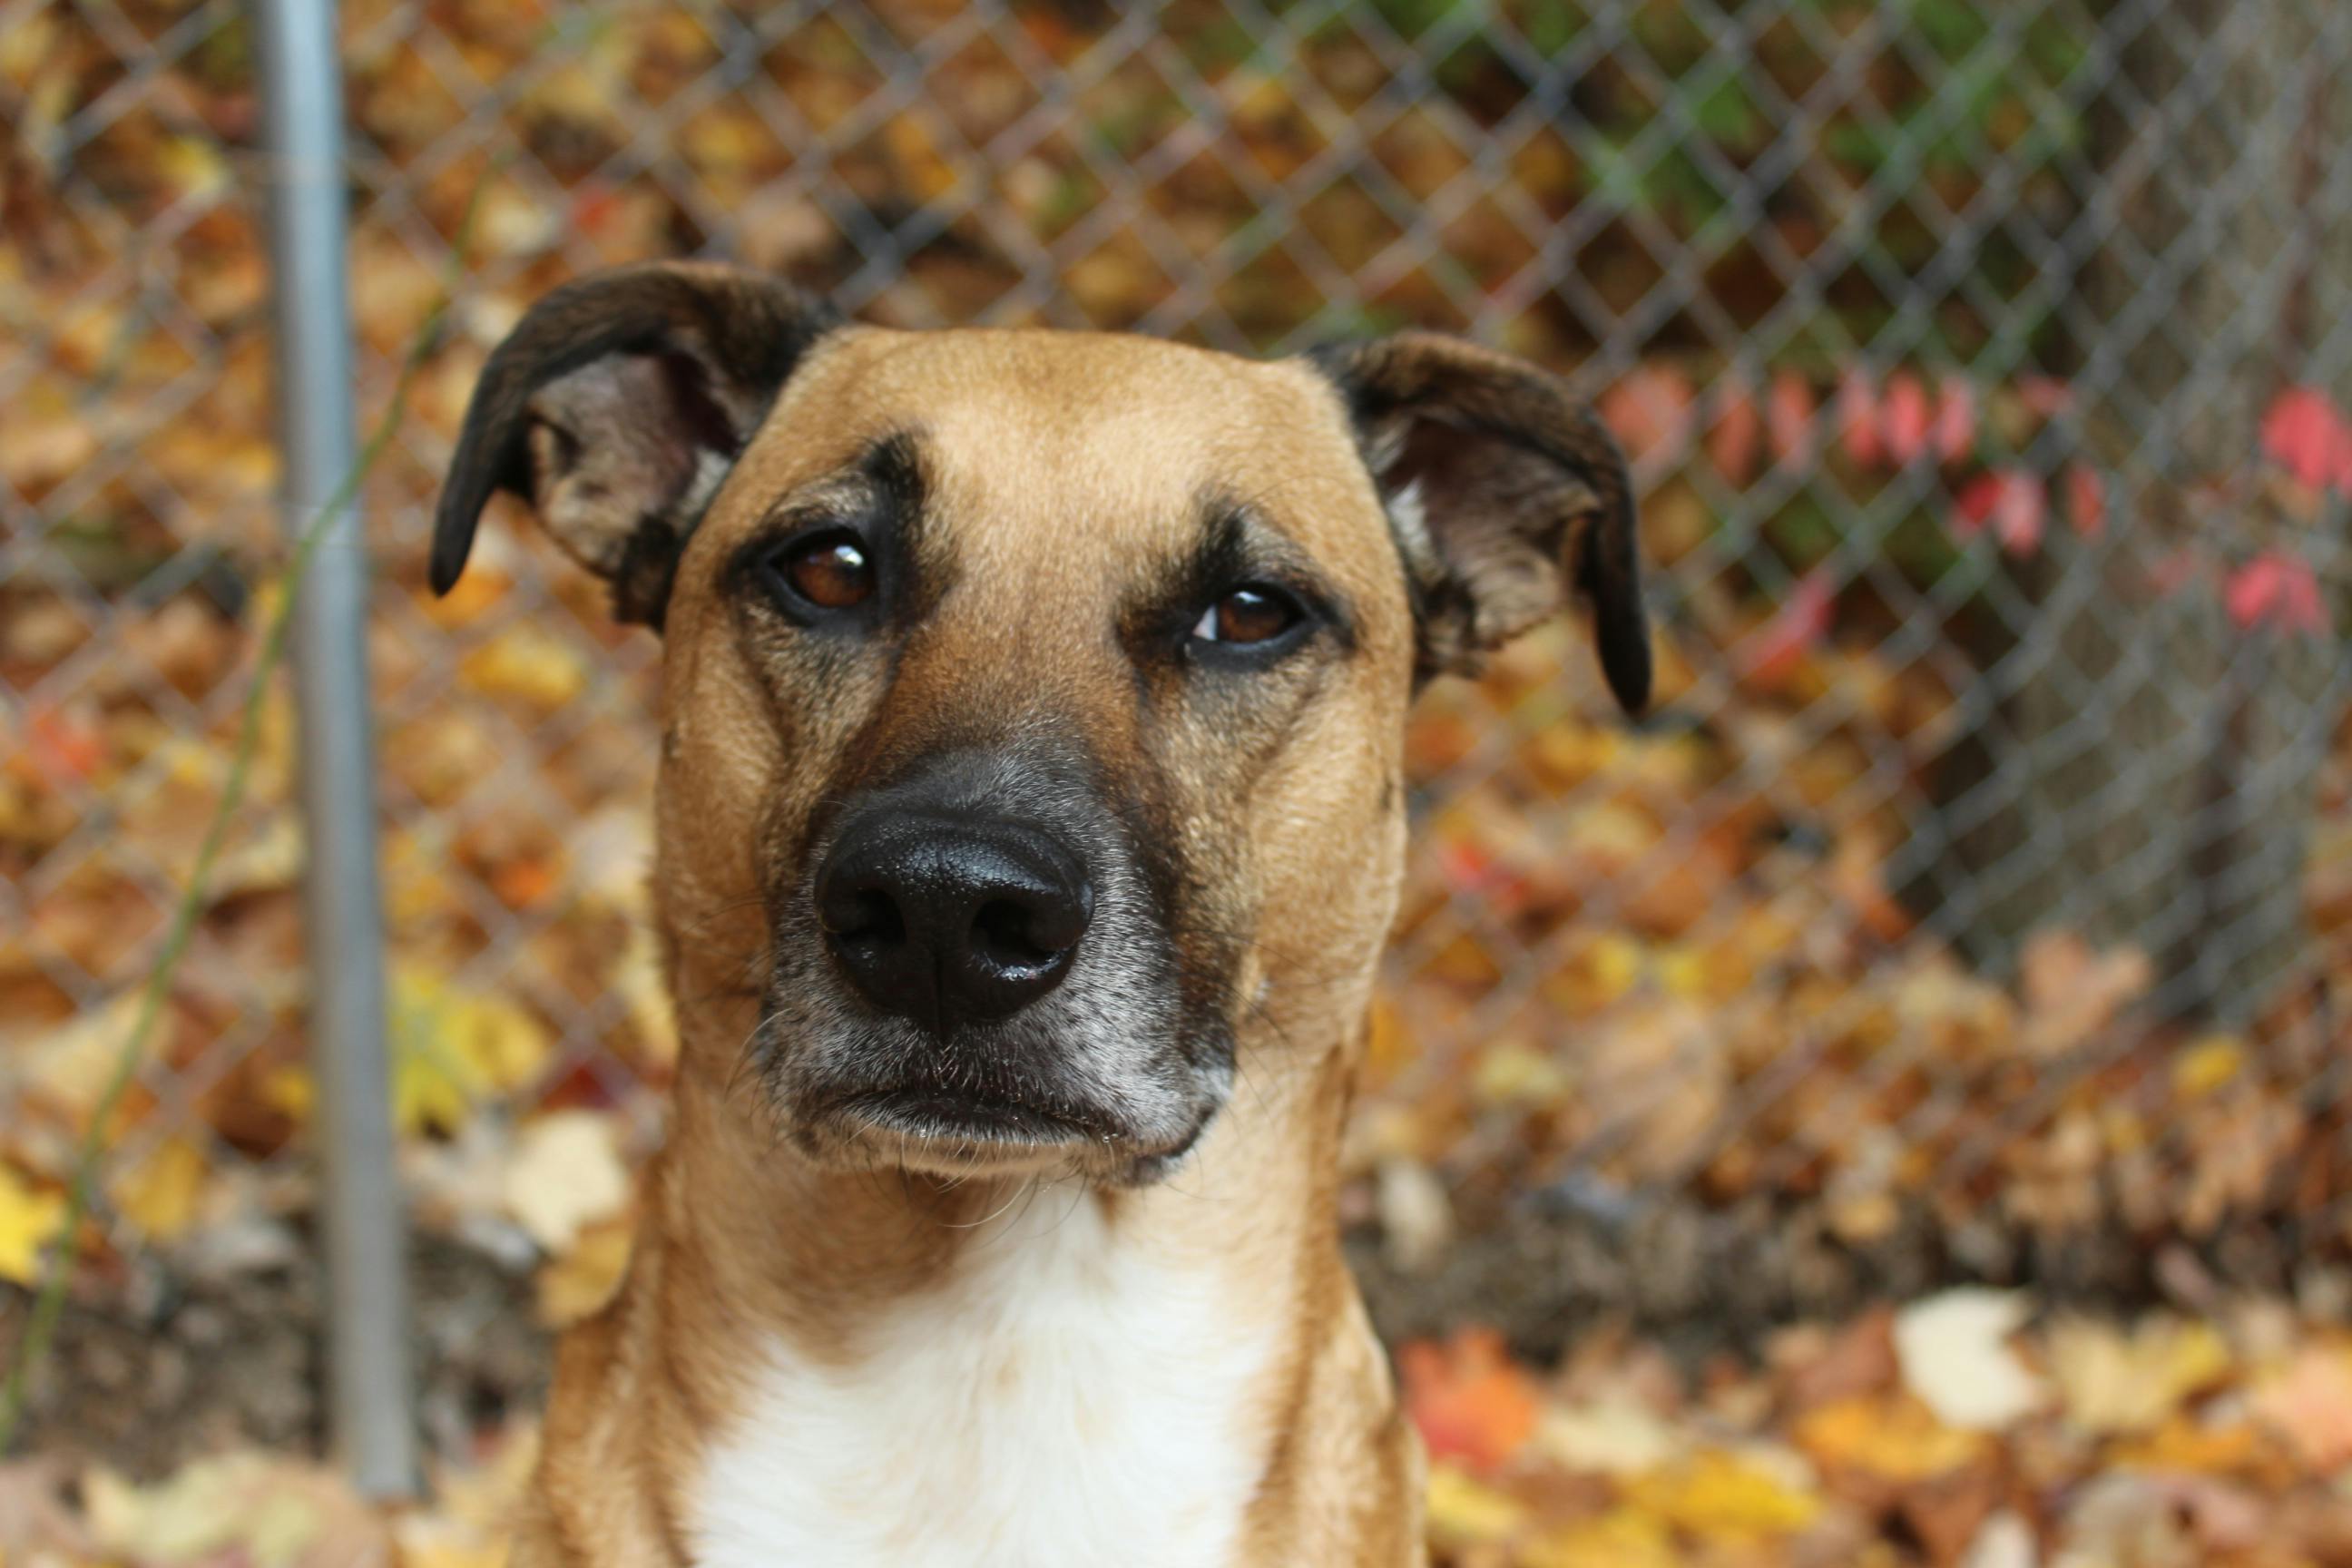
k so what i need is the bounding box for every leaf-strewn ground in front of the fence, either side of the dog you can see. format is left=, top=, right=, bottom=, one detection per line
left=18, top=1289, right=2352, bottom=1568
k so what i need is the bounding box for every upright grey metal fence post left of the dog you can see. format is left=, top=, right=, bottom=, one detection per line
left=254, top=0, right=416, bottom=1495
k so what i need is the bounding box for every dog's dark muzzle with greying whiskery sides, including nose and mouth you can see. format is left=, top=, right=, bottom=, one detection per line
left=755, top=750, right=1232, bottom=1181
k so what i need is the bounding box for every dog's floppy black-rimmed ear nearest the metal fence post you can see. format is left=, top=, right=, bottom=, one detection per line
left=433, top=263, right=839, bottom=628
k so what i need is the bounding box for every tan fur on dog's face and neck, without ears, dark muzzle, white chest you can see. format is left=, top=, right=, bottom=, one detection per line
left=475, top=329, right=1421, bottom=1568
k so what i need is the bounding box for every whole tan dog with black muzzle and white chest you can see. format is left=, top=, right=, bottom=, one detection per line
left=433, top=266, right=1649, bottom=1568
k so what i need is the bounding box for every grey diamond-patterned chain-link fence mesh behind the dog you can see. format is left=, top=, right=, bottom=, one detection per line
left=0, top=0, right=2352, bottom=1447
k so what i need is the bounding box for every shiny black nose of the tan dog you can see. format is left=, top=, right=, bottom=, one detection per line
left=816, top=811, right=1093, bottom=1030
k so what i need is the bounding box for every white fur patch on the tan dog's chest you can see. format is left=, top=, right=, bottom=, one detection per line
left=691, top=1191, right=1272, bottom=1568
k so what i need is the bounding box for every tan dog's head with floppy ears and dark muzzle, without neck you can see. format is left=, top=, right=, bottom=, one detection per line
left=433, top=266, right=1649, bottom=1181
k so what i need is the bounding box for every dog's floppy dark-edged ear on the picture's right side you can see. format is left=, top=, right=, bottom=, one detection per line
left=1310, top=331, right=1649, bottom=712
